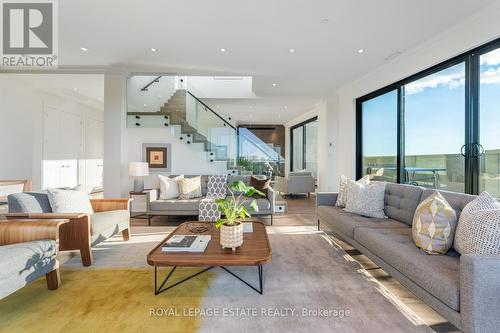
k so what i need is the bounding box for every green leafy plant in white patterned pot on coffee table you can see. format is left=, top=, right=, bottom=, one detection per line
left=215, top=181, right=265, bottom=251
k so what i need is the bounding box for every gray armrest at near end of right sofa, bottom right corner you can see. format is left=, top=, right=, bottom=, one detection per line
left=460, top=254, right=500, bottom=333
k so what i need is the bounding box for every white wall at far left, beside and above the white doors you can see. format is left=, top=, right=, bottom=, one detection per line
left=0, top=74, right=102, bottom=189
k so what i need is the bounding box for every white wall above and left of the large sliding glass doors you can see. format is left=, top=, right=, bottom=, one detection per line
left=327, top=2, right=500, bottom=190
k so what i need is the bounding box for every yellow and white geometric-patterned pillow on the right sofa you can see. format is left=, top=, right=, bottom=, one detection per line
left=412, top=192, right=457, bottom=254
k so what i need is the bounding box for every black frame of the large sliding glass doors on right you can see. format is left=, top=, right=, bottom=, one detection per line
left=356, top=38, right=500, bottom=194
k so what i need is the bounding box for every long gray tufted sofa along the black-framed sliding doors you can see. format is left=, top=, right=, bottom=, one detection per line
left=317, top=183, right=500, bottom=333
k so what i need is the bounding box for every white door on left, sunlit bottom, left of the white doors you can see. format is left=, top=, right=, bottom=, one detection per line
left=42, top=106, right=82, bottom=188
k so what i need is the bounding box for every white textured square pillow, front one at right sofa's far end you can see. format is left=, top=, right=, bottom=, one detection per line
left=344, top=179, right=387, bottom=218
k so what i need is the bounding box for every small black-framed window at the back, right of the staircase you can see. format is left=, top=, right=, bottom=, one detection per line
left=290, top=117, right=318, bottom=178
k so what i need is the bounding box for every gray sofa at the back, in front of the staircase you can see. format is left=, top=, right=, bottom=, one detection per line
left=147, top=175, right=276, bottom=225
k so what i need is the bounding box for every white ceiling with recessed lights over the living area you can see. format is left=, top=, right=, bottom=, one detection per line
left=59, top=0, right=494, bottom=98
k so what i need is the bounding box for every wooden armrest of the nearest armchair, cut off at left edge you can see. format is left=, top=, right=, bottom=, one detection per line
left=0, top=219, right=69, bottom=245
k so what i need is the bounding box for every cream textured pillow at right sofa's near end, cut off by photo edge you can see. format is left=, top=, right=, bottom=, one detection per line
left=454, top=192, right=500, bottom=254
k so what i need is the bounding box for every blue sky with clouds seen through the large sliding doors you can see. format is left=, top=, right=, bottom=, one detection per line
left=363, top=49, right=500, bottom=156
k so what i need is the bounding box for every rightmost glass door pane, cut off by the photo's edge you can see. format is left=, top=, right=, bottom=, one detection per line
left=474, top=49, right=500, bottom=198
